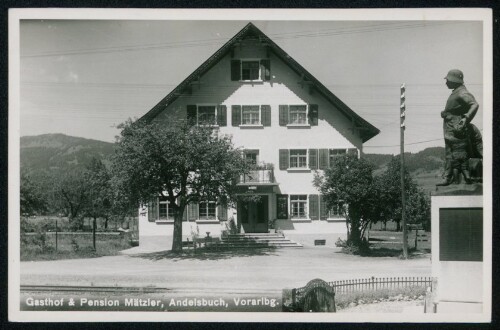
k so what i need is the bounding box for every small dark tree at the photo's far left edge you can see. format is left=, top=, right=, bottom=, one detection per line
left=20, top=170, right=47, bottom=215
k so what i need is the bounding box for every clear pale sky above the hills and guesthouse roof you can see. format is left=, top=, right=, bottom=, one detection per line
left=19, top=14, right=491, bottom=154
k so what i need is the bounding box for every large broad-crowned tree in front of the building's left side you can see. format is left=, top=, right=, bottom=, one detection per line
left=112, top=120, right=249, bottom=251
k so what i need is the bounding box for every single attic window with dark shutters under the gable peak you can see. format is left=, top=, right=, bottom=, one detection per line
left=231, top=59, right=271, bottom=81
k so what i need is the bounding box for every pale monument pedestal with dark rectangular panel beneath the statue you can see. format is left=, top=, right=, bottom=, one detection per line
left=431, top=184, right=484, bottom=313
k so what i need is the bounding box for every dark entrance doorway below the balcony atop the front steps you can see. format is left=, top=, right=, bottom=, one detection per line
left=238, top=196, right=269, bottom=233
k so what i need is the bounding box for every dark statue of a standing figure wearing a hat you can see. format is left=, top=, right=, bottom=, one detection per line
left=436, top=70, right=483, bottom=186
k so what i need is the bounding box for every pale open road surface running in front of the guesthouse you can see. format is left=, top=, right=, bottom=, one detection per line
left=21, top=247, right=431, bottom=295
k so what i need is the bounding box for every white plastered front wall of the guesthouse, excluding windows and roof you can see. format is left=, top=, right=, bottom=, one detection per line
left=139, top=24, right=376, bottom=242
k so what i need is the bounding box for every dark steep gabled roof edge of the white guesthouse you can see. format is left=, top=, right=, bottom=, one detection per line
left=139, top=23, right=380, bottom=142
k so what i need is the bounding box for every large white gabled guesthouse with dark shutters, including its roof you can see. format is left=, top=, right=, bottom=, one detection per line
left=139, top=23, right=379, bottom=244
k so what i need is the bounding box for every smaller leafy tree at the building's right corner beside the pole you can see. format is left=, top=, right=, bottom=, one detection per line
left=313, top=155, right=379, bottom=246
